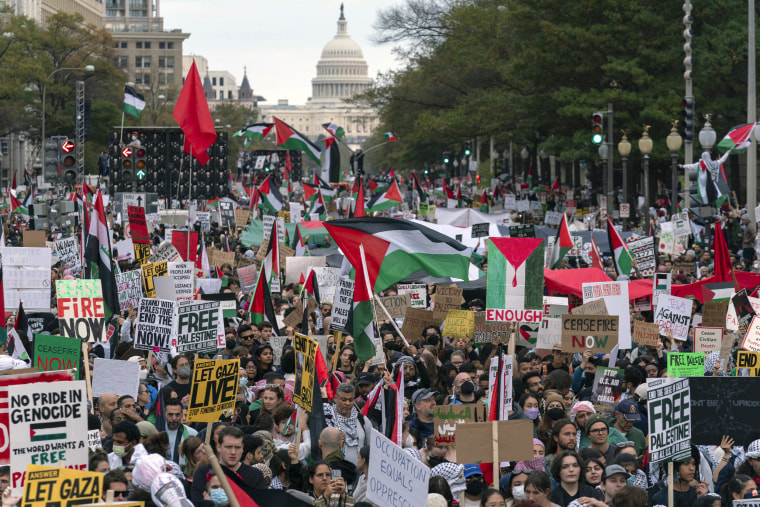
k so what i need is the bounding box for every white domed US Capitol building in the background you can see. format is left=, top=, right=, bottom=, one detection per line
left=259, top=4, right=378, bottom=149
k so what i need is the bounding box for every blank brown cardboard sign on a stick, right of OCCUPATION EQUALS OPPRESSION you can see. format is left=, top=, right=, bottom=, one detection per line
left=452, top=419, right=533, bottom=466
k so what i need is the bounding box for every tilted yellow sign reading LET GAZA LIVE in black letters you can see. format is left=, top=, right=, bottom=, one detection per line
left=187, top=359, right=240, bottom=423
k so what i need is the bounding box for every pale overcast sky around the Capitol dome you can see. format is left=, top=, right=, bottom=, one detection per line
left=160, top=0, right=401, bottom=104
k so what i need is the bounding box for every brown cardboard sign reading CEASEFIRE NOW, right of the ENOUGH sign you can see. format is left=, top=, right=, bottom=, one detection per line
left=562, top=314, right=620, bottom=354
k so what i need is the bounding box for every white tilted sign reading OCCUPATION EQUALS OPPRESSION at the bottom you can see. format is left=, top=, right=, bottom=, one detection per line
left=367, top=428, right=430, bottom=505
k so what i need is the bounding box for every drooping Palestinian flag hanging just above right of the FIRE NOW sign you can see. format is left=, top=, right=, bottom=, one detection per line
left=84, top=189, right=119, bottom=322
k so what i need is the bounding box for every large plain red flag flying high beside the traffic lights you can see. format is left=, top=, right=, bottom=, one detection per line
left=172, top=60, right=216, bottom=166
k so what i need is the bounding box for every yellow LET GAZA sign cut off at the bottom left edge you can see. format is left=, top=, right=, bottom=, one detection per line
left=20, top=465, right=103, bottom=507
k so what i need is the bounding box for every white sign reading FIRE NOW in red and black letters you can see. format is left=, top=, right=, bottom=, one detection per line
left=55, top=279, right=106, bottom=342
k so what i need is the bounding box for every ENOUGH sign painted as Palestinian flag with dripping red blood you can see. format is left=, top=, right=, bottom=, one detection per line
left=486, top=238, right=544, bottom=322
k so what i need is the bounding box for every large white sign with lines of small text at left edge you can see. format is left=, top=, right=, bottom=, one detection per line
left=0, top=247, right=52, bottom=312
